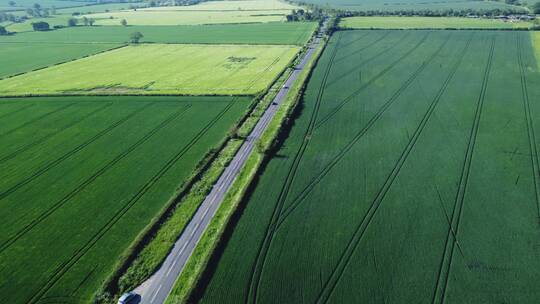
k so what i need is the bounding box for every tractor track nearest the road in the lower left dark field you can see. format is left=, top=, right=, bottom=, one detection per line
left=28, top=97, right=237, bottom=303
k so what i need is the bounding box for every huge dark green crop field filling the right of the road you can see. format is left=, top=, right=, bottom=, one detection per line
left=193, top=30, right=540, bottom=303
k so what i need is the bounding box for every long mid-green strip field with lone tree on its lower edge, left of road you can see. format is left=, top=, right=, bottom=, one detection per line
left=0, top=22, right=317, bottom=45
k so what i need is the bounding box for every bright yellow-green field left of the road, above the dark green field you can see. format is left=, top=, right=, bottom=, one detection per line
left=0, top=44, right=299, bottom=96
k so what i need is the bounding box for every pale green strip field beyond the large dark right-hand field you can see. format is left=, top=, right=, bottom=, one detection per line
left=340, top=17, right=532, bottom=29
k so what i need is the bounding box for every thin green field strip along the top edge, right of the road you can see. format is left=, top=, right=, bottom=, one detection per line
left=298, top=0, right=524, bottom=11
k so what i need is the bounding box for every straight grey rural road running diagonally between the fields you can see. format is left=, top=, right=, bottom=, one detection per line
left=134, top=22, right=326, bottom=304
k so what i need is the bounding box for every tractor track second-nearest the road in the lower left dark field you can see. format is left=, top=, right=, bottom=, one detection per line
left=0, top=106, right=190, bottom=253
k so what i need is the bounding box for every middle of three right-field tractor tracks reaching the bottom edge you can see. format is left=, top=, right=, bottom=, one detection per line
left=316, top=31, right=472, bottom=303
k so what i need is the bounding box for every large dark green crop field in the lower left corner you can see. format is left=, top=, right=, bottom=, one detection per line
left=0, top=97, right=250, bottom=303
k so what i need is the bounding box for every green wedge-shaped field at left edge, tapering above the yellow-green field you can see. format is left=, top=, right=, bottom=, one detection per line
left=0, top=42, right=119, bottom=78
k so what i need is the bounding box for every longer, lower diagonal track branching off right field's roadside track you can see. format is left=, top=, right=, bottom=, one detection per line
left=276, top=34, right=451, bottom=230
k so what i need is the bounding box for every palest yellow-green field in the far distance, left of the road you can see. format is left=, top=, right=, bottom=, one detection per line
left=82, top=0, right=299, bottom=25
